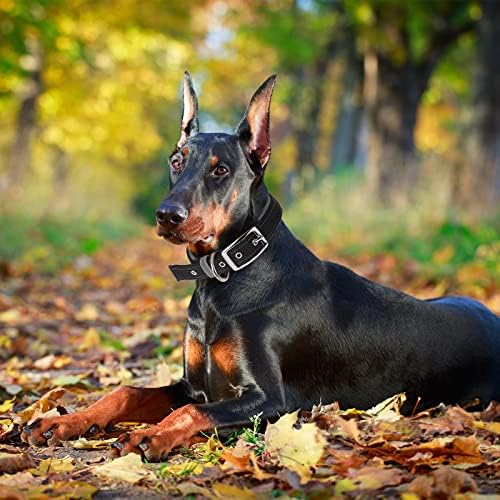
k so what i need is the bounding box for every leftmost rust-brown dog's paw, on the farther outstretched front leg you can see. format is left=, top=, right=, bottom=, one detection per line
left=21, top=413, right=100, bottom=446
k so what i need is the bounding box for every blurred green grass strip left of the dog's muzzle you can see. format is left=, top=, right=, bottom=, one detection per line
left=0, top=213, right=142, bottom=273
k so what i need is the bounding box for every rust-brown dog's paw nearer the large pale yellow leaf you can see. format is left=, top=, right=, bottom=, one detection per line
left=110, top=426, right=176, bottom=462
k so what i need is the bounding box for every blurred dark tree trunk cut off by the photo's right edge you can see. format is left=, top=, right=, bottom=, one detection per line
left=462, top=0, right=500, bottom=212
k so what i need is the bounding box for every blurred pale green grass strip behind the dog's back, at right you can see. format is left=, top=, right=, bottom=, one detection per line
left=285, top=170, right=500, bottom=279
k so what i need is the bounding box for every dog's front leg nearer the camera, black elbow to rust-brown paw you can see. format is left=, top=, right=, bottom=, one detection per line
left=112, top=389, right=284, bottom=462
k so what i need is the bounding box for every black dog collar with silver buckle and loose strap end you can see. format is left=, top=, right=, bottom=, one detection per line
left=169, top=195, right=282, bottom=282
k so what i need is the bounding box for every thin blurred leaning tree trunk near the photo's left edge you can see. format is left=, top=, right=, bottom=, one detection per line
left=7, top=44, right=43, bottom=188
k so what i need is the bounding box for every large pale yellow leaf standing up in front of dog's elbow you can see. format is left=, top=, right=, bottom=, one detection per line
left=264, top=411, right=326, bottom=482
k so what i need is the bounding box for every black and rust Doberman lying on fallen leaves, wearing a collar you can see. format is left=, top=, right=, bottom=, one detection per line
left=22, top=73, right=500, bottom=461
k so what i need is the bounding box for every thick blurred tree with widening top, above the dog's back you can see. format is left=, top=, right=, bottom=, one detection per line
left=346, top=0, right=475, bottom=204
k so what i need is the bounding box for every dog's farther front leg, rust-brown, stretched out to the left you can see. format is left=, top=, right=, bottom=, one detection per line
left=21, top=381, right=190, bottom=446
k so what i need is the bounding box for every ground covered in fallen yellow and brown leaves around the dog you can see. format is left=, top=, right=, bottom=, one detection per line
left=0, top=233, right=500, bottom=500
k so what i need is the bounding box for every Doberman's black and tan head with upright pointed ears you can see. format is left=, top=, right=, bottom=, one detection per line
left=156, top=72, right=276, bottom=254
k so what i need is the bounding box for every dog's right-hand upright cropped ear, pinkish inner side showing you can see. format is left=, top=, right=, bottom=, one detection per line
left=236, top=75, right=276, bottom=169
